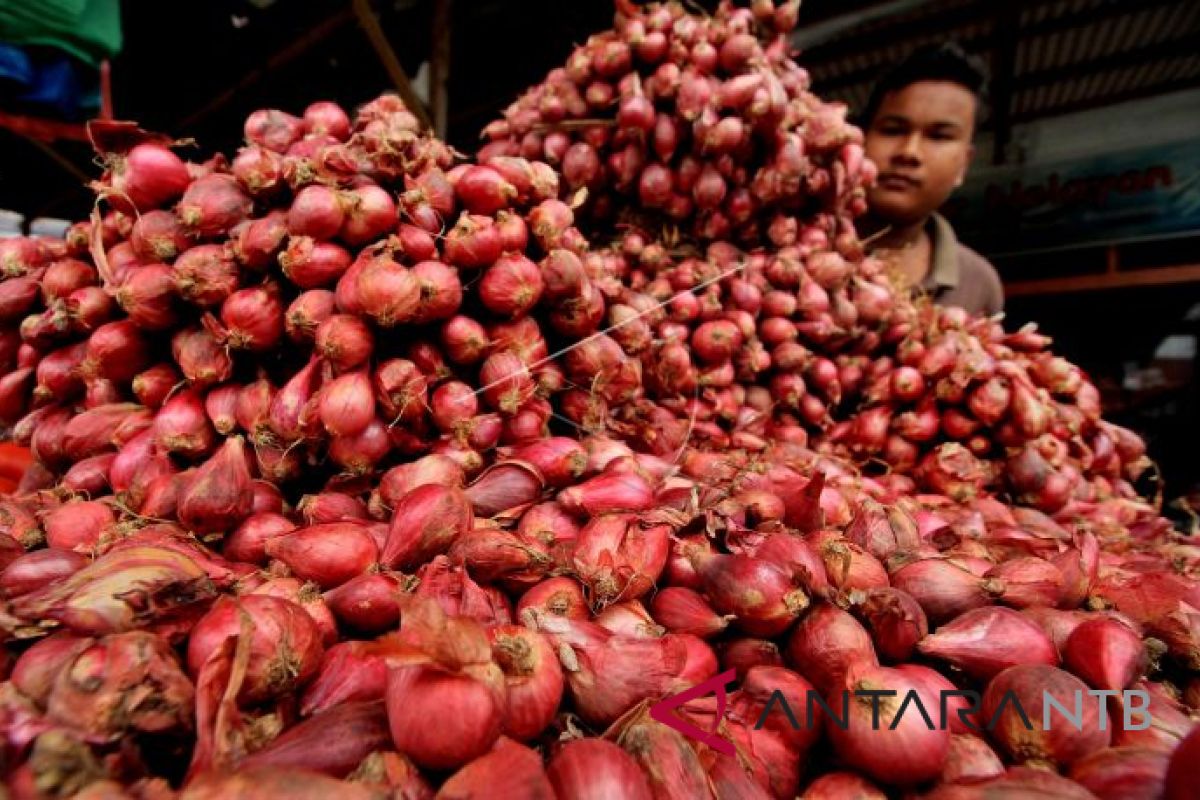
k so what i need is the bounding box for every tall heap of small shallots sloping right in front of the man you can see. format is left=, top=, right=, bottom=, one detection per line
left=479, top=2, right=1146, bottom=512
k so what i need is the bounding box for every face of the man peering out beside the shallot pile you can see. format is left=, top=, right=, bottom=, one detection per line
left=866, top=80, right=976, bottom=225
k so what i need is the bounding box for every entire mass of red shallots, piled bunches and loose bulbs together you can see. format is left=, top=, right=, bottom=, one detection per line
left=0, top=2, right=1200, bottom=800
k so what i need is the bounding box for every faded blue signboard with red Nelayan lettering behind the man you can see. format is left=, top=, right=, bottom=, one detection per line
left=944, top=142, right=1200, bottom=255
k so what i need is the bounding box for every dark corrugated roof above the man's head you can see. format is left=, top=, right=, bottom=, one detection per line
left=800, top=0, right=1200, bottom=131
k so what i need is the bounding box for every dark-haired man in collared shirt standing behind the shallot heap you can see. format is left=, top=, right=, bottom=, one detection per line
left=862, top=44, right=1004, bottom=314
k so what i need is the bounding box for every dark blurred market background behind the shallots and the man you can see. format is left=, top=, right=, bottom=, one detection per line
left=0, top=0, right=1200, bottom=507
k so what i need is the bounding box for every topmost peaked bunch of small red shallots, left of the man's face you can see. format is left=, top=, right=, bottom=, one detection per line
left=479, top=0, right=875, bottom=247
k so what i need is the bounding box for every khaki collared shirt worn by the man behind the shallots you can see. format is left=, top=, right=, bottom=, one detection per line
left=920, top=213, right=1004, bottom=317
